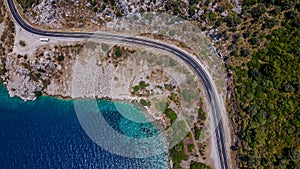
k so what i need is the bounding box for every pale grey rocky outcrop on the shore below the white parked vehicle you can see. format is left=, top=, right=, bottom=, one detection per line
left=2, top=45, right=80, bottom=101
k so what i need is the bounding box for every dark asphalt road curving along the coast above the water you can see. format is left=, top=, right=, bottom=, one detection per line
left=7, top=0, right=229, bottom=169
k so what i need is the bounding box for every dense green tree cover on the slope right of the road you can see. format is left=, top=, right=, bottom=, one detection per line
left=232, top=0, right=300, bottom=168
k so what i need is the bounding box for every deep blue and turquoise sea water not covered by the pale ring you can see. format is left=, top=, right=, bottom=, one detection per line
left=0, top=85, right=167, bottom=169
